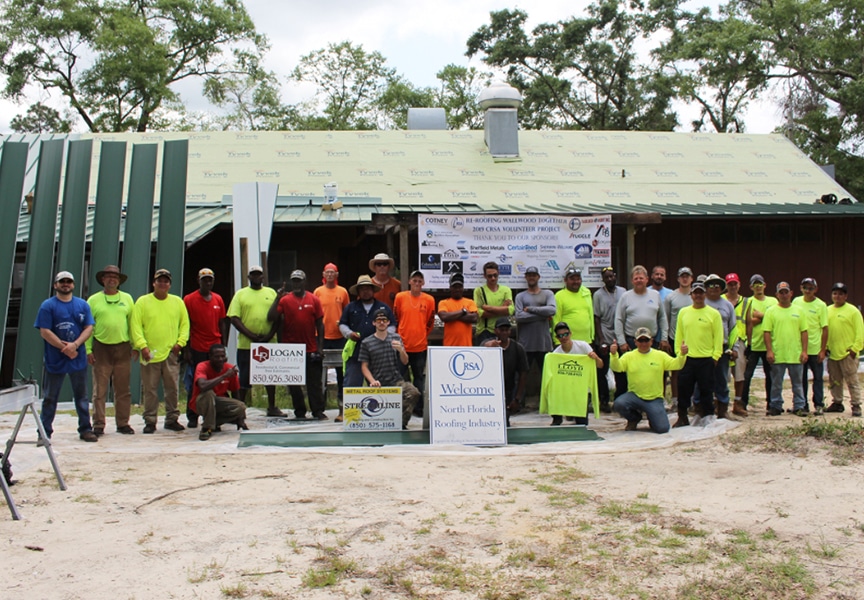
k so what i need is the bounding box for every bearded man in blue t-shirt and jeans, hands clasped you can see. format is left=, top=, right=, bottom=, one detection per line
left=33, top=271, right=99, bottom=442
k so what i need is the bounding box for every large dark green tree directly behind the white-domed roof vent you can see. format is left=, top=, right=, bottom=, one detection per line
left=467, top=0, right=677, bottom=130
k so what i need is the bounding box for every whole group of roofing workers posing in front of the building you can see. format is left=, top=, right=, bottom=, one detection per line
left=35, top=253, right=864, bottom=442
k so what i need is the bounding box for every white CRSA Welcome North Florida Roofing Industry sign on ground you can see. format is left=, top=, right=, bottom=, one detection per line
left=428, top=346, right=507, bottom=446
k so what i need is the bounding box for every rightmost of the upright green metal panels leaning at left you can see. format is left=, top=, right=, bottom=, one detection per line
left=156, top=140, right=189, bottom=296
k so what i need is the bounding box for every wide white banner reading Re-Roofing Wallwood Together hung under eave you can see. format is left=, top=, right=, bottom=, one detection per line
left=417, top=214, right=612, bottom=289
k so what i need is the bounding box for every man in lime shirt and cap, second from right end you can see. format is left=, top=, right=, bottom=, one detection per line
left=792, top=277, right=828, bottom=415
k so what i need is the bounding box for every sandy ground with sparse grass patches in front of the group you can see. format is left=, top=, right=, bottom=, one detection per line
left=0, top=398, right=864, bottom=600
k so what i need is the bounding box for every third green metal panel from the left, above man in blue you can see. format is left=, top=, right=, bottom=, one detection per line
left=57, top=140, right=93, bottom=288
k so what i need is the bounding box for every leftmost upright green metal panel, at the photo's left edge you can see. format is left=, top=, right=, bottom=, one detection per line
left=0, top=142, right=28, bottom=368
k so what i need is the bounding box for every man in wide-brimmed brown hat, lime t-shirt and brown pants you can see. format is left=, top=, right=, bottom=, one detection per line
left=86, top=265, right=138, bottom=436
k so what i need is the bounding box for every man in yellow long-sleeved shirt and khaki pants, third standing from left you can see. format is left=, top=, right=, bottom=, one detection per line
left=130, top=269, right=189, bottom=433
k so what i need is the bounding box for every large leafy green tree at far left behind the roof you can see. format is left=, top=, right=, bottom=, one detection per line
left=0, top=0, right=265, bottom=132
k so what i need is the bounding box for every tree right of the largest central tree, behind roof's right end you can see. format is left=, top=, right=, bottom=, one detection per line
left=654, top=2, right=771, bottom=133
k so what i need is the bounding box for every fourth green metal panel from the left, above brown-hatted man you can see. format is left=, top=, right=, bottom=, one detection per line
left=88, top=142, right=126, bottom=294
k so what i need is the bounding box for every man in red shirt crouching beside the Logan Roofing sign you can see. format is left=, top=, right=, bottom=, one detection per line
left=189, top=344, right=249, bottom=441
